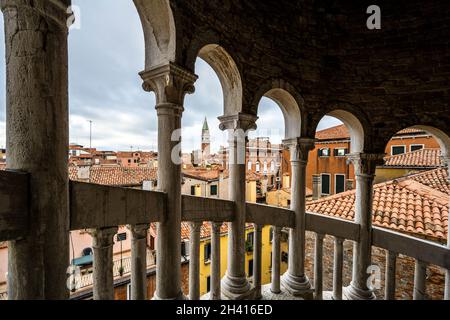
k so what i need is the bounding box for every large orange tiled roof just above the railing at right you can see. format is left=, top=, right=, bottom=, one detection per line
left=306, top=179, right=449, bottom=241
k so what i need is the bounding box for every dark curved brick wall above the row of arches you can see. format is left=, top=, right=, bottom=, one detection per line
left=163, top=0, right=450, bottom=152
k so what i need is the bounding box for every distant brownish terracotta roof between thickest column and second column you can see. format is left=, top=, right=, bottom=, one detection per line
left=69, top=166, right=157, bottom=186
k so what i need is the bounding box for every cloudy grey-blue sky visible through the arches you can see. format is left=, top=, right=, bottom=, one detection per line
left=0, top=0, right=339, bottom=152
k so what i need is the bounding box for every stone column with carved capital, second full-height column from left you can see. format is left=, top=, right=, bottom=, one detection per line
left=141, top=63, right=197, bottom=300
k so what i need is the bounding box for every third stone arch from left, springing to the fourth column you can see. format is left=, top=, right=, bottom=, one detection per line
left=253, top=79, right=304, bottom=139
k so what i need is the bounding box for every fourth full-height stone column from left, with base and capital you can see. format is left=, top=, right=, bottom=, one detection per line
left=281, top=138, right=315, bottom=299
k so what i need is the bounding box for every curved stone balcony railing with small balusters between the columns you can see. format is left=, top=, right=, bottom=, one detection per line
left=0, top=171, right=450, bottom=299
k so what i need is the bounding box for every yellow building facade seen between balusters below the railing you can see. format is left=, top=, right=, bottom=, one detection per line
left=200, top=226, right=288, bottom=295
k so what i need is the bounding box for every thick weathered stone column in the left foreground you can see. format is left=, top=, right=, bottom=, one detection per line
left=0, top=0, right=70, bottom=300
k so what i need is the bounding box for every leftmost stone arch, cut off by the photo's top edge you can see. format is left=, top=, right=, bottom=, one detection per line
left=133, top=0, right=177, bottom=70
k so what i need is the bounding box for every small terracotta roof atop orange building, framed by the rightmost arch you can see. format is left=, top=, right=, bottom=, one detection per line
left=384, top=149, right=442, bottom=168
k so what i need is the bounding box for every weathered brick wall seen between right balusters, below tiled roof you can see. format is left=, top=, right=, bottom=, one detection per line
left=305, top=232, right=445, bottom=300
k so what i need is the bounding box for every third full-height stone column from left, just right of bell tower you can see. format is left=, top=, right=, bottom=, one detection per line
left=219, top=113, right=257, bottom=300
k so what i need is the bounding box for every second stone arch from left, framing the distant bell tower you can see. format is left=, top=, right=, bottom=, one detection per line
left=197, top=44, right=243, bottom=116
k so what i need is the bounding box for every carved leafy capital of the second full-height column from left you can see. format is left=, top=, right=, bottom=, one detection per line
left=139, top=62, right=198, bottom=106
